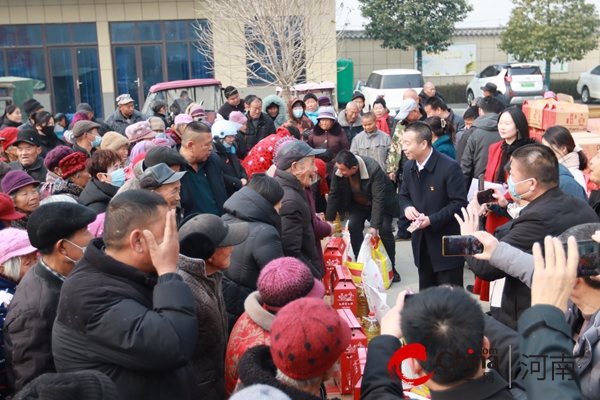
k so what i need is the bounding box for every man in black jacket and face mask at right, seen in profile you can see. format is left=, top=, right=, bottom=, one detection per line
left=466, top=143, right=598, bottom=330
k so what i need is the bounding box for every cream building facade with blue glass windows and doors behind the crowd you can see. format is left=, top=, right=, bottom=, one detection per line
left=0, top=0, right=336, bottom=117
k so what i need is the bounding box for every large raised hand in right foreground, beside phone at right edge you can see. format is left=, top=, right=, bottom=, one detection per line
left=531, top=236, right=579, bottom=313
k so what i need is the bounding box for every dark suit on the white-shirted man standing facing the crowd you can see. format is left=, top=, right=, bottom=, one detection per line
left=400, top=148, right=468, bottom=272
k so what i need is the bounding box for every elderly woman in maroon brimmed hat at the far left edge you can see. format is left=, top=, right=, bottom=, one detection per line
left=2, top=171, right=40, bottom=230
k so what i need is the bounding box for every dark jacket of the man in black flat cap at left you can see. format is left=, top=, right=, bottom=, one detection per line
left=4, top=260, right=63, bottom=392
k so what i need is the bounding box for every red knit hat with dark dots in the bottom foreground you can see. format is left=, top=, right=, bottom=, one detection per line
left=270, top=297, right=351, bottom=380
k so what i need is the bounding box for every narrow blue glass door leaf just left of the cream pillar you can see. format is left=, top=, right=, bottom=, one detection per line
left=76, top=48, right=104, bottom=118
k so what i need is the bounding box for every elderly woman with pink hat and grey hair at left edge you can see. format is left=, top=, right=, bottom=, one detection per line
left=0, top=228, right=37, bottom=398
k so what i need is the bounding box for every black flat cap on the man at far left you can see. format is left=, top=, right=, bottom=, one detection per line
left=27, top=202, right=96, bottom=249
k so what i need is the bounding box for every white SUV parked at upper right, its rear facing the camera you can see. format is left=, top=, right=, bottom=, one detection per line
left=467, top=63, right=548, bottom=104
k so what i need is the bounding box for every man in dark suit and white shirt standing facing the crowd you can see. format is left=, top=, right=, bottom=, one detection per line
left=400, top=121, right=467, bottom=290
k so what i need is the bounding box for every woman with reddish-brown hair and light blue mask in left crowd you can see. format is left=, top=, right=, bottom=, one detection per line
left=78, top=150, right=125, bottom=214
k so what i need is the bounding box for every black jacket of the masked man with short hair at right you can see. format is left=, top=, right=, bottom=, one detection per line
left=467, top=187, right=598, bottom=330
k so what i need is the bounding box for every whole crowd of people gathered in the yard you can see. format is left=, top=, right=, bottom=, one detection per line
left=0, top=82, right=600, bottom=400
